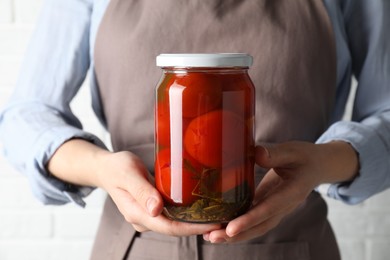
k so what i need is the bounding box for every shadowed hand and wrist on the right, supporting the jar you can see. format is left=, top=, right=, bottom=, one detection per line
left=203, top=141, right=358, bottom=243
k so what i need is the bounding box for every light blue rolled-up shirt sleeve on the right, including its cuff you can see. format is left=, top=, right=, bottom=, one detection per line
left=318, top=0, right=390, bottom=204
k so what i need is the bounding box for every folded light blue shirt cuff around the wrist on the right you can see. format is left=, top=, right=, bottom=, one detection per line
left=317, top=121, right=390, bottom=204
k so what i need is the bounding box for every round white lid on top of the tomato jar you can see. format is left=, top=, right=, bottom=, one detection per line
left=156, top=53, right=253, bottom=67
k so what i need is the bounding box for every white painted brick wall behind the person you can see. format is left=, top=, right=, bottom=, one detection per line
left=0, top=0, right=390, bottom=260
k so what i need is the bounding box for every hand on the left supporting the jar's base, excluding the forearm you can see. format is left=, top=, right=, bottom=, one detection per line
left=98, top=151, right=220, bottom=236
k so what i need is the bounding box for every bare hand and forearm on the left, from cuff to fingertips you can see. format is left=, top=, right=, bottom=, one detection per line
left=48, top=139, right=220, bottom=236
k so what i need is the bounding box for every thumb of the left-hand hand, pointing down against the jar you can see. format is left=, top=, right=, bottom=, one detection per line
left=125, top=165, right=163, bottom=217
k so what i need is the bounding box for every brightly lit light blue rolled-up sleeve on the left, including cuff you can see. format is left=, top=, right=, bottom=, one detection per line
left=0, top=0, right=104, bottom=206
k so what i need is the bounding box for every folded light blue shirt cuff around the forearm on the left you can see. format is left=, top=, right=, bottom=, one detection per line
left=26, top=126, right=106, bottom=207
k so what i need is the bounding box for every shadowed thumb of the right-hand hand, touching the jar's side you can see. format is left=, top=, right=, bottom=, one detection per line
left=255, top=143, right=298, bottom=168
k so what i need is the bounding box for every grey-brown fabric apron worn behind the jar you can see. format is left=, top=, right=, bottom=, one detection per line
left=91, top=0, right=340, bottom=260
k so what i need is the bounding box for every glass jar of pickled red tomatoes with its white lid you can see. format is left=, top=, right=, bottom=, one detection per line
left=155, top=54, right=255, bottom=223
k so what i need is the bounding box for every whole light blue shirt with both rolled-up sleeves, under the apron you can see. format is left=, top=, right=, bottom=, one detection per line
left=0, top=0, right=390, bottom=205
